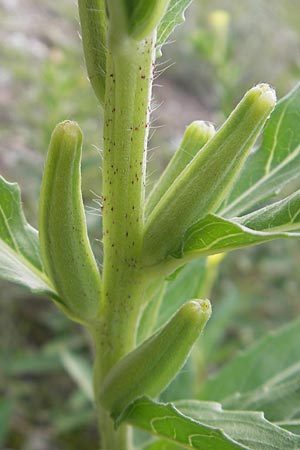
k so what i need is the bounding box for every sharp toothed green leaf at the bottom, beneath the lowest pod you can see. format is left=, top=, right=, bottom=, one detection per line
left=119, top=397, right=300, bottom=450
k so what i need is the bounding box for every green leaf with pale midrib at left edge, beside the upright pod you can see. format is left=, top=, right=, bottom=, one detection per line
left=0, top=177, right=57, bottom=298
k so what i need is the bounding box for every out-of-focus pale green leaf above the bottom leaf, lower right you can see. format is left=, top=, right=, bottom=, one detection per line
left=201, top=320, right=300, bottom=414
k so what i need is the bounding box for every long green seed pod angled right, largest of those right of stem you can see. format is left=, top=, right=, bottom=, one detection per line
left=143, top=84, right=276, bottom=266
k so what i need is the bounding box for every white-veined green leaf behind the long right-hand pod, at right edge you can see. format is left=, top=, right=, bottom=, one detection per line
left=218, top=84, right=300, bottom=217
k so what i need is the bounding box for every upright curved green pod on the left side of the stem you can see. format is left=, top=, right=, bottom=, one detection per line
left=39, top=121, right=101, bottom=323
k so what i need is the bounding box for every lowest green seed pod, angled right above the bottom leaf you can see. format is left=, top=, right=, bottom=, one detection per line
left=98, top=300, right=211, bottom=418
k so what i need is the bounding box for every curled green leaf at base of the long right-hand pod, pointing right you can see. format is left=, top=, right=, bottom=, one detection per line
left=178, top=214, right=300, bottom=259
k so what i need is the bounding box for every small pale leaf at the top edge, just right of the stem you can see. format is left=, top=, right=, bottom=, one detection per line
left=156, top=0, right=192, bottom=56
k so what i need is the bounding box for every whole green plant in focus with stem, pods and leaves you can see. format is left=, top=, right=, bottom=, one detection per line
left=0, top=0, right=300, bottom=450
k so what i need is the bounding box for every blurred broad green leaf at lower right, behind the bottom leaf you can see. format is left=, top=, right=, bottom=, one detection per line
left=201, top=320, right=300, bottom=421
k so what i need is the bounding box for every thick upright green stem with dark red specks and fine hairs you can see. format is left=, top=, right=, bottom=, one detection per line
left=93, top=33, right=154, bottom=450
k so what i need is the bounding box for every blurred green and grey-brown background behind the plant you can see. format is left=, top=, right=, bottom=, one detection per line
left=0, top=0, right=300, bottom=450
